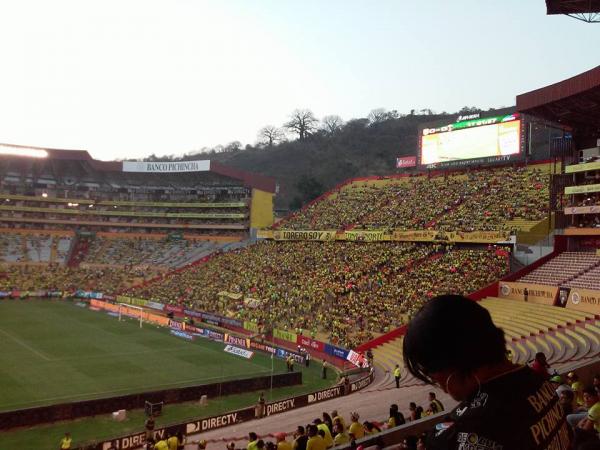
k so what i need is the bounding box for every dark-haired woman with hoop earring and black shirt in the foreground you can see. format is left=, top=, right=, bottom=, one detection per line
left=403, top=295, right=571, bottom=450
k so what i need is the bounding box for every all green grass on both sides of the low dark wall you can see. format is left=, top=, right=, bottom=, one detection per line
left=0, top=300, right=334, bottom=449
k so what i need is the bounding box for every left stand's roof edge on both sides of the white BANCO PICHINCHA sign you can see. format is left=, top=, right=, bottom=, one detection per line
left=0, top=143, right=276, bottom=193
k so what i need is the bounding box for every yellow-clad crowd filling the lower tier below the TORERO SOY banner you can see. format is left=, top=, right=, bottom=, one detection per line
left=127, top=241, right=508, bottom=347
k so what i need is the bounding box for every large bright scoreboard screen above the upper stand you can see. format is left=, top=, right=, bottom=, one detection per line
left=421, top=114, right=521, bottom=165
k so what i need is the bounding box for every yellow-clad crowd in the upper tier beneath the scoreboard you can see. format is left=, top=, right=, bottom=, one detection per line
left=279, top=167, right=550, bottom=231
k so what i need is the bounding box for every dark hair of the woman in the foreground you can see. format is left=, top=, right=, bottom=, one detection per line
left=403, top=295, right=506, bottom=384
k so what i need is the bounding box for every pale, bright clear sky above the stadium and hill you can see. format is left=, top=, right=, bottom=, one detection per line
left=0, top=0, right=600, bottom=160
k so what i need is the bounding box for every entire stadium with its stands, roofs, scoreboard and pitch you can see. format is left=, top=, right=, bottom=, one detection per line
left=0, top=1, right=600, bottom=450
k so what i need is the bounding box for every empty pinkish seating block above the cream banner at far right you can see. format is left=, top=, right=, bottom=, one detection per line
left=519, top=252, right=600, bottom=286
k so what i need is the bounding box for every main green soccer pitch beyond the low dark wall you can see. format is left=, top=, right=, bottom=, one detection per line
left=0, top=299, right=285, bottom=411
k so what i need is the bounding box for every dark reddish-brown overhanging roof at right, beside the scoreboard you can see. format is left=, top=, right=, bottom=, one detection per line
left=517, top=66, right=600, bottom=132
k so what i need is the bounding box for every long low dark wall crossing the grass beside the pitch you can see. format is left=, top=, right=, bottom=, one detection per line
left=0, top=372, right=302, bottom=430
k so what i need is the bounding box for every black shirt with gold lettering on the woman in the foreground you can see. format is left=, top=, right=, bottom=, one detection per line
left=427, top=367, right=571, bottom=450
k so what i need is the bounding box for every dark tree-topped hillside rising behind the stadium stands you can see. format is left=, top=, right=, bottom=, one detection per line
left=138, top=108, right=504, bottom=210
